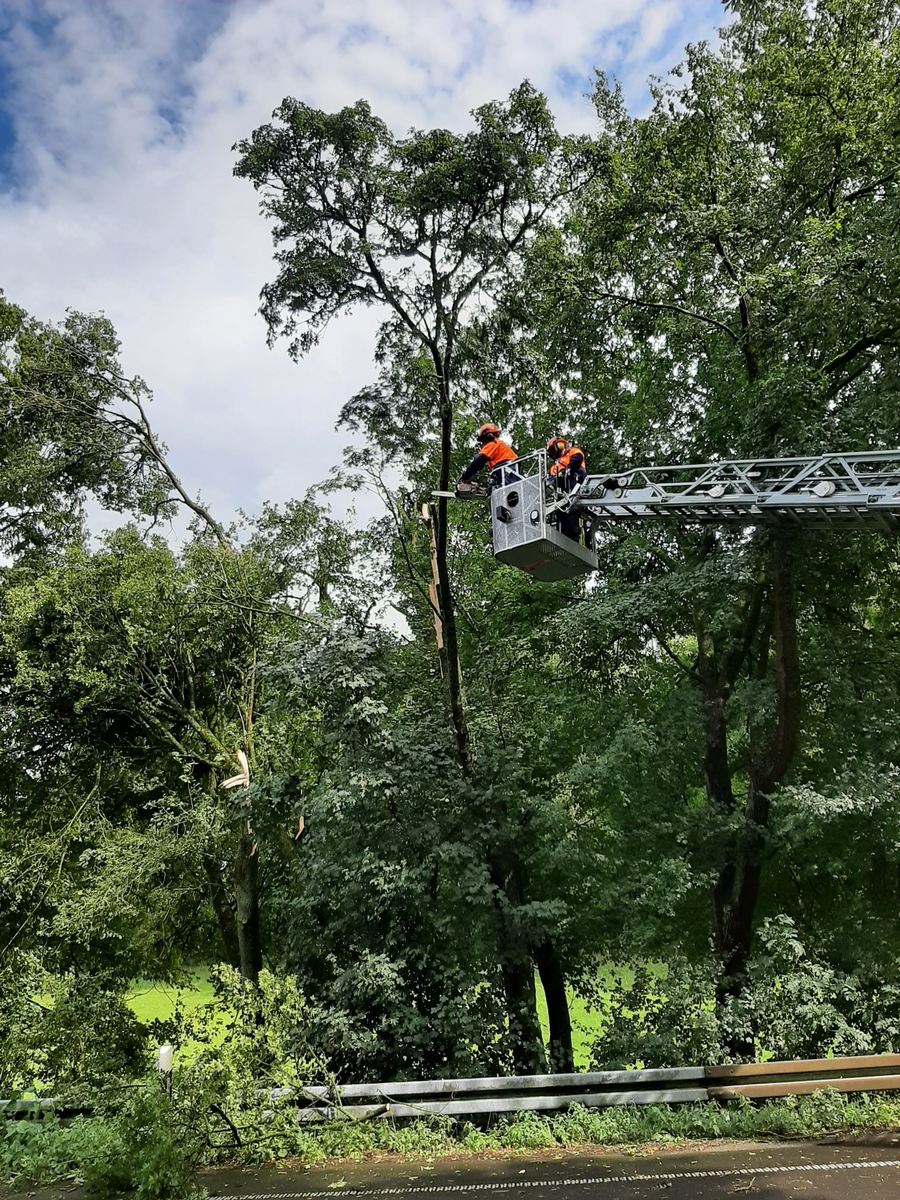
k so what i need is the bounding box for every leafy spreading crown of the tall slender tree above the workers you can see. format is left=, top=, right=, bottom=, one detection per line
left=234, top=83, right=602, bottom=362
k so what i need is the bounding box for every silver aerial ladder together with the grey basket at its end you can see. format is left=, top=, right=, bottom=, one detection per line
left=468, top=450, right=900, bottom=582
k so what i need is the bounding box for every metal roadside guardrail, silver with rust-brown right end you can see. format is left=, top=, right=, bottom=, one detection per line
left=7, top=1055, right=900, bottom=1122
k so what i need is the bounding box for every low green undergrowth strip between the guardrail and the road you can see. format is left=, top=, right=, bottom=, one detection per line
left=0, top=1091, right=900, bottom=1200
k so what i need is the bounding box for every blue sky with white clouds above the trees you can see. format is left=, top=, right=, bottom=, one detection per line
left=0, top=0, right=724, bottom=535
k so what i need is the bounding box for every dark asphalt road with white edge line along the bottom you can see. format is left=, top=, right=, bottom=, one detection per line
left=203, top=1134, right=900, bottom=1200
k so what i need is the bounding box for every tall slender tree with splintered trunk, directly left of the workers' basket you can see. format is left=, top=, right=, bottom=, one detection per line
left=235, top=83, right=605, bottom=1069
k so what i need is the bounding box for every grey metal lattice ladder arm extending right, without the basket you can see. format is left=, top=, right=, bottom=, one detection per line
left=572, top=450, right=900, bottom=533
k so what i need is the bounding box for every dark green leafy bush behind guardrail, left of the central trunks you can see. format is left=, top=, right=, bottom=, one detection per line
left=260, top=625, right=513, bottom=1080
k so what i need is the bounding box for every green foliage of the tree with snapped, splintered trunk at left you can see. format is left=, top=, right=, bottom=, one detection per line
left=0, top=503, right=374, bottom=983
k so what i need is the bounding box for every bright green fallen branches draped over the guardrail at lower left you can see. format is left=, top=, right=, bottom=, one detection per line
left=2, top=967, right=329, bottom=1200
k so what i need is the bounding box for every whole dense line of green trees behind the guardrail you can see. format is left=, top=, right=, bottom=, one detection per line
left=0, top=0, right=900, bottom=1092
